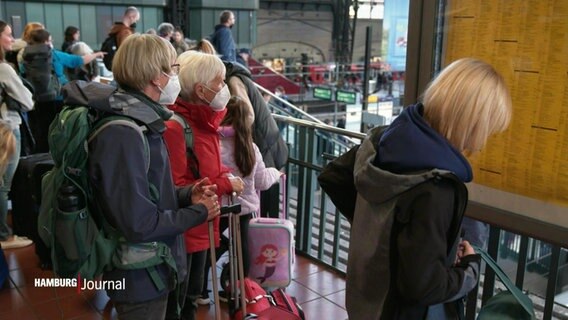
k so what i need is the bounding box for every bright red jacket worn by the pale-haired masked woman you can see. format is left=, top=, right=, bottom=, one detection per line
left=164, top=98, right=233, bottom=253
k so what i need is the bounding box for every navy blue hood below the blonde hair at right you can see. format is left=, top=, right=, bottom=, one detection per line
left=373, top=104, right=473, bottom=182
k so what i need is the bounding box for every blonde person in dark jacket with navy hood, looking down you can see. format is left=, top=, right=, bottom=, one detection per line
left=344, top=58, right=512, bottom=320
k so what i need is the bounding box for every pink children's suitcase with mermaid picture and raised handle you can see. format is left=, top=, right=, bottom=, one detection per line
left=248, top=175, right=295, bottom=288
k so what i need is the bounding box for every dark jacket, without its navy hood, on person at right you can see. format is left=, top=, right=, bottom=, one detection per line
left=346, top=126, right=479, bottom=320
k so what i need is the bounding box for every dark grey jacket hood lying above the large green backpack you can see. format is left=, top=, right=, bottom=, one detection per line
left=62, top=80, right=173, bottom=133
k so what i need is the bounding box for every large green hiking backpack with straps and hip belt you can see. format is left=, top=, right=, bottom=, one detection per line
left=38, top=99, right=177, bottom=290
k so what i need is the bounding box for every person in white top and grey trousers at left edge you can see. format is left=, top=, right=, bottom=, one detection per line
left=0, top=20, right=33, bottom=249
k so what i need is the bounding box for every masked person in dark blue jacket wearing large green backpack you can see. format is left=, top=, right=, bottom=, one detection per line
left=50, top=34, right=220, bottom=320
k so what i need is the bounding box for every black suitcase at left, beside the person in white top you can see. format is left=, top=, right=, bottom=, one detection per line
left=10, top=153, right=54, bottom=268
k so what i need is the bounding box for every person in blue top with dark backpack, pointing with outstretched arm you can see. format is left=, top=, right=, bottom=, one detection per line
left=20, top=29, right=104, bottom=152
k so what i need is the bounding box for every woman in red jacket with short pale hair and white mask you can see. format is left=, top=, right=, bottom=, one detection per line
left=164, top=51, right=244, bottom=319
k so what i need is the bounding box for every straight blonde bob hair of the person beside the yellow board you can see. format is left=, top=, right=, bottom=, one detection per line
left=422, top=58, right=512, bottom=155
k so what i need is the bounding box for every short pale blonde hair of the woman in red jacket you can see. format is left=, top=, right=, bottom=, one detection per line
left=177, top=51, right=225, bottom=100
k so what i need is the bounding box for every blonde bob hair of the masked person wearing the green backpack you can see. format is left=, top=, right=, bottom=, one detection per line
left=112, top=33, right=177, bottom=91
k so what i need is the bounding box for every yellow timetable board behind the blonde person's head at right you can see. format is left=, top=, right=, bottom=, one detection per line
left=444, top=0, right=568, bottom=206
